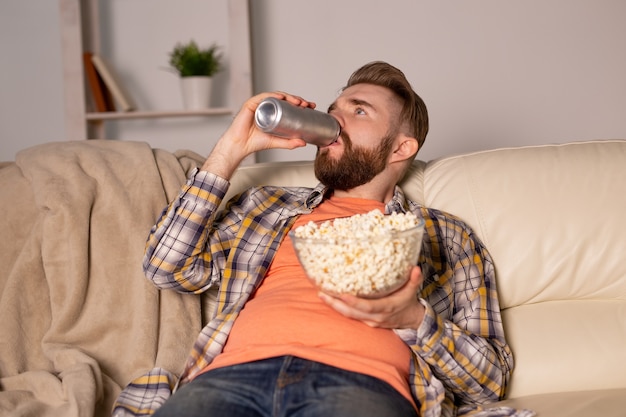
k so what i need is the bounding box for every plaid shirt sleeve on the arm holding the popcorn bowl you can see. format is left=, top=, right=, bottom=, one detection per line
left=397, top=208, right=513, bottom=410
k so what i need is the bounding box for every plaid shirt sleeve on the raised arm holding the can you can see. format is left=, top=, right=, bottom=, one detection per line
left=143, top=170, right=229, bottom=293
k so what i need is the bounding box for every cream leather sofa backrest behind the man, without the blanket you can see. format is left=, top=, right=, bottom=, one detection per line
left=229, top=140, right=626, bottom=397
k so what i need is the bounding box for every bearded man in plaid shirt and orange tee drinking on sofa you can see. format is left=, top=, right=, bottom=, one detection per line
left=116, top=62, right=513, bottom=417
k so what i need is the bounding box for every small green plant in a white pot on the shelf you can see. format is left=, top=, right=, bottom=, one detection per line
left=169, top=40, right=222, bottom=109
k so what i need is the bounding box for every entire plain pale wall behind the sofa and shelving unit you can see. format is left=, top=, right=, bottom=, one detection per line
left=0, top=0, right=626, bottom=161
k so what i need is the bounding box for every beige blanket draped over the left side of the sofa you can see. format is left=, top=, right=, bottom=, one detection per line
left=0, top=141, right=202, bottom=417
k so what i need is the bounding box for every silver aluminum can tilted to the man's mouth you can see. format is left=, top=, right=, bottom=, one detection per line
left=254, top=97, right=341, bottom=146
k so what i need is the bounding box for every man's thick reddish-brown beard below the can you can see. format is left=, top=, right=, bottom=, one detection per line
left=314, top=131, right=395, bottom=191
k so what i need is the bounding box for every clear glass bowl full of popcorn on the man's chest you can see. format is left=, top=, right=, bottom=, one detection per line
left=289, top=210, right=424, bottom=298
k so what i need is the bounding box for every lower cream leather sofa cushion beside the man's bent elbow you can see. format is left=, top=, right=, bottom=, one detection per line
left=503, top=300, right=626, bottom=398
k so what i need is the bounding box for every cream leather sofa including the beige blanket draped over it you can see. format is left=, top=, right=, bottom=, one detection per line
left=0, top=140, right=626, bottom=417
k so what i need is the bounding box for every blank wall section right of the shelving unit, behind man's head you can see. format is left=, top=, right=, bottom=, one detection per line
left=254, top=0, right=626, bottom=159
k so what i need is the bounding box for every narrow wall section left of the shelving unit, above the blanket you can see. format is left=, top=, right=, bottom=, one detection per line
left=0, top=0, right=65, bottom=161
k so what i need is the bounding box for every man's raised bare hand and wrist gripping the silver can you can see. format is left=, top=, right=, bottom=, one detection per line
left=201, top=91, right=315, bottom=180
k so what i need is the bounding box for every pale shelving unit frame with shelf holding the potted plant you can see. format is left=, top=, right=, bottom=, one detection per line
left=58, top=0, right=252, bottom=140
